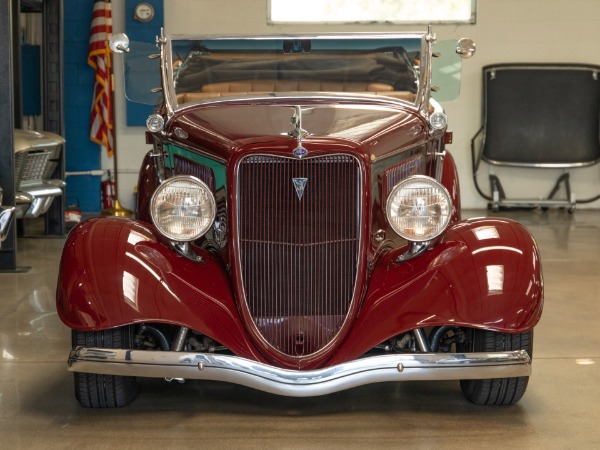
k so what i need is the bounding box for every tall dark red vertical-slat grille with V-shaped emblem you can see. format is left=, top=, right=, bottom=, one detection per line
left=238, top=155, right=361, bottom=356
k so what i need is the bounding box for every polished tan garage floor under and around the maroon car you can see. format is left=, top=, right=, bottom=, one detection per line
left=0, top=210, right=600, bottom=449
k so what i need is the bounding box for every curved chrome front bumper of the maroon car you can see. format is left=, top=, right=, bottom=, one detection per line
left=69, top=347, right=531, bottom=397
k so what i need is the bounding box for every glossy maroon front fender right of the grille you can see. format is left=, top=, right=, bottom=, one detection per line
left=328, top=218, right=543, bottom=364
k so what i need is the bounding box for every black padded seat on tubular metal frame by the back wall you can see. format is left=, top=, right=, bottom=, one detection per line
left=471, top=64, right=600, bottom=212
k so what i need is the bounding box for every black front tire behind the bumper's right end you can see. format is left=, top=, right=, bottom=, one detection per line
left=459, top=330, right=533, bottom=405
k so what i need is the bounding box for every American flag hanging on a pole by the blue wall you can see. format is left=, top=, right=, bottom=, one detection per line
left=88, top=0, right=113, bottom=156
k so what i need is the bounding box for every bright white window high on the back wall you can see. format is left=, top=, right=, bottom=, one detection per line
left=269, top=0, right=476, bottom=24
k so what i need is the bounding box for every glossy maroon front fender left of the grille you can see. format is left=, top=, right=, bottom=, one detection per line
left=57, top=218, right=264, bottom=361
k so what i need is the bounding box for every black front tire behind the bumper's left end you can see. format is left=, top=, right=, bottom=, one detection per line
left=72, top=326, right=137, bottom=408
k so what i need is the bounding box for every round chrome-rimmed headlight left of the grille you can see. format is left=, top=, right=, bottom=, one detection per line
left=150, top=175, right=216, bottom=242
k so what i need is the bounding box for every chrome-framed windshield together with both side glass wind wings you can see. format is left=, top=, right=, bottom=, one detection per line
left=124, top=33, right=460, bottom=107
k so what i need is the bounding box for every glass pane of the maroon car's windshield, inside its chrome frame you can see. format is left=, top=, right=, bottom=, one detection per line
left=172, top=37, right=421, bottom=103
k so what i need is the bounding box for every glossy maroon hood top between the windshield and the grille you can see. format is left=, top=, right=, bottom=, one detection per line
left=166, top=100, right=427, bottom=160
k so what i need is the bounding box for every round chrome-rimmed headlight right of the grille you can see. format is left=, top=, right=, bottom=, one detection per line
left=385, top=175, right=452, bottom=242
